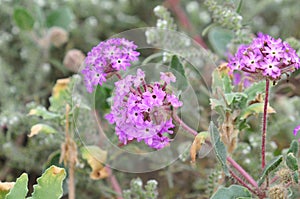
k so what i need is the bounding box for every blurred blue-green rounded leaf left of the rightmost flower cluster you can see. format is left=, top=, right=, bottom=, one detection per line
left=208, top=27, right=234, bottom=57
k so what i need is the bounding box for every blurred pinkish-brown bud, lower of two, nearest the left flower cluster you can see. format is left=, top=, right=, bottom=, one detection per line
left=63, top=49, right=85, bottom=72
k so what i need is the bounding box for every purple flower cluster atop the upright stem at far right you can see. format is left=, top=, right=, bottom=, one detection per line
left=228, top=33, right=300, bottom=80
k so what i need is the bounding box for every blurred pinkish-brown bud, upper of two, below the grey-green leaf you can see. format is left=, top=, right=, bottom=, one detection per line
left=48, top=27, right=69, bottom=48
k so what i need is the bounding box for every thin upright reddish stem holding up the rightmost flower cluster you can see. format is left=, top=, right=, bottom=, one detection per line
left=261, top=79, right=270, bottom=169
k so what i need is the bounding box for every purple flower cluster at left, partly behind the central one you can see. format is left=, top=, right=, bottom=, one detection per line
left=82, top=38, right=140, bottom=93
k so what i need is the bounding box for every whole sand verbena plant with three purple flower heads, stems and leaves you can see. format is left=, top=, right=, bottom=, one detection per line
left=82, top=21, right=300, bottom=199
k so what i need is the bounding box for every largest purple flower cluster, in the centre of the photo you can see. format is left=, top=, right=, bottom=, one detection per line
left=105, top=69, right=182, bottom=149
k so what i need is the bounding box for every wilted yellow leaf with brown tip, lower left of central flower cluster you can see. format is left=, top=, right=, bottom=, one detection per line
left=81, top=146, right=108, bottom=180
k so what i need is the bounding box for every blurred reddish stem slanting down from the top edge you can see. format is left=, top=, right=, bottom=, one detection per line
left=166, top=0, right=207, bottom=49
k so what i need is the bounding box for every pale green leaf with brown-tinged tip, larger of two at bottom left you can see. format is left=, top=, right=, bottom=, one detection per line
left=31, top=166, right=66, bottom=199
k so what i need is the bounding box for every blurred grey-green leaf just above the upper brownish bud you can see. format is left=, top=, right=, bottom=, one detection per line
left=46, top=7, right=74, bottom=30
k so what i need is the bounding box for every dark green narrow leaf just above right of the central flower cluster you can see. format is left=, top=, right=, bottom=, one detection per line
left=171, top=55, right=188, bottom=91
